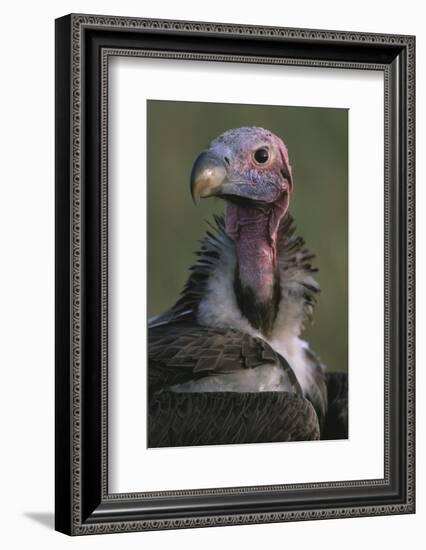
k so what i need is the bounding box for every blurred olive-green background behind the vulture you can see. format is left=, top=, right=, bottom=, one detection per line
left=147, top=100, right=348, bottom=376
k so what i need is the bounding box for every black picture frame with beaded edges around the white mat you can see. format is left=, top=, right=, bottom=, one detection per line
left=55, top=14, right=415, bottom=535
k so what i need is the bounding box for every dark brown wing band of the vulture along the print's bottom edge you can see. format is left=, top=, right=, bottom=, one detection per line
left=148, top=392, right=320, bottom=447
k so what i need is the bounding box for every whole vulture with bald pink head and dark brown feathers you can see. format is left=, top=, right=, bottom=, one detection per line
left=148, top=127, right=347, bottom=447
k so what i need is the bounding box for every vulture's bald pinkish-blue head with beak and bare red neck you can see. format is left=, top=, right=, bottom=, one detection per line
left=191, top=127, right=293, bottom=334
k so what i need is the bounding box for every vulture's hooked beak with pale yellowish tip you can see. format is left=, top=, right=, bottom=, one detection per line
left=191, top=150, right=227, bottom=204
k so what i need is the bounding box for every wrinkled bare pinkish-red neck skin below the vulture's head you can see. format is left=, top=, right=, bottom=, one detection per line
left=225, top=197, right=288, bottom=336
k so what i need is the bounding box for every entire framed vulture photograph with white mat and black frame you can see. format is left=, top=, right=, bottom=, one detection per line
left=55, top=14, right=415, bottom=535
